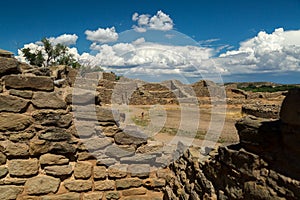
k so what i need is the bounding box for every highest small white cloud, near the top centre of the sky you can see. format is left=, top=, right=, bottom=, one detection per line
left=132, top=10, right=174, bottom=32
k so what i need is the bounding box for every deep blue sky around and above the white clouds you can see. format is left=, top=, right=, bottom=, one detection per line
left=0, top=0, right=300, bottom=82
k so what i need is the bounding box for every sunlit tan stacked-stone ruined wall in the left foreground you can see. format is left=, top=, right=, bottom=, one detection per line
left=0, top=58, right=165, bottom=200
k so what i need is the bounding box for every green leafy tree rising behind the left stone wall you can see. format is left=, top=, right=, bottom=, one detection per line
left=21, top=38, right=81, bottom=68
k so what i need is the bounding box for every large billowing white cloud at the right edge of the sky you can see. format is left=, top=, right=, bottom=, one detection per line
left=216, top=28, right=300, bottom=74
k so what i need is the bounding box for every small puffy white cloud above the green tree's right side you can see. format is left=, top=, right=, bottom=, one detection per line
left=85, top=27, right=119, bottom=43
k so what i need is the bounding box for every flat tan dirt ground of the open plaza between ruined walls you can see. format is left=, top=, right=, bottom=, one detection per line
left=115, top=105, right=242, bottom=146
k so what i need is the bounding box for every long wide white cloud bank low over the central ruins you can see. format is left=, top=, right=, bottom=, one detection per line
left=78, top=38, right=219, bottom=77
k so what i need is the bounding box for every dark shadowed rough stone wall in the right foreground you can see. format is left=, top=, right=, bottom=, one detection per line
left=164, top=90, right=300, bottom=200
